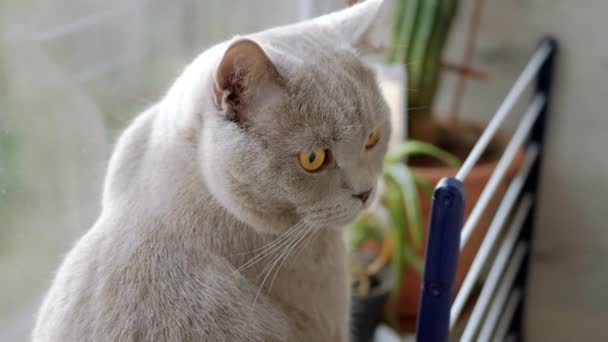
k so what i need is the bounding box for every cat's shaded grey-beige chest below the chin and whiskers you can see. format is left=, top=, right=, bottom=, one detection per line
left=211, top=222, right=350, bottom=341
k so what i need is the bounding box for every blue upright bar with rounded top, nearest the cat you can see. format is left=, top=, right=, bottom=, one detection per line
left=416, top=178, right=466, bottom=342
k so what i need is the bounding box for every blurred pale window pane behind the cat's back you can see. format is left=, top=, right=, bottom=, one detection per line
left=0, top=0, right=345, bottom=341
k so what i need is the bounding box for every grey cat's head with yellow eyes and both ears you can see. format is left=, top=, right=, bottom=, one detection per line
left=200, top=0, right=391, bottom=232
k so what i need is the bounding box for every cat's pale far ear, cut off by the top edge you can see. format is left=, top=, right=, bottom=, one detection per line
left=317, top=0, right=390, bottom=51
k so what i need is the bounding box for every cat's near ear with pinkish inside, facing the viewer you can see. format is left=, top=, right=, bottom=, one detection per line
left=213, top=39, right=283, bottom=123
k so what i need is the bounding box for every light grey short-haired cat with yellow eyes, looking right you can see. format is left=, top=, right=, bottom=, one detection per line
left=32, top=0, right=391, bottom=342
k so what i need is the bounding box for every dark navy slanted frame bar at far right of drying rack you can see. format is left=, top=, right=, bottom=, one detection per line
left=510, top=37, right=558, bottom=341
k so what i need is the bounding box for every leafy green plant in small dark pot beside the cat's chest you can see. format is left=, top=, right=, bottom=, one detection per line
left=349, top=141, right=460, bottom=341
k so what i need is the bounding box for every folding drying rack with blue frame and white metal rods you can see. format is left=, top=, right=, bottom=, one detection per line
left=416, top=38, right=557, bottom=342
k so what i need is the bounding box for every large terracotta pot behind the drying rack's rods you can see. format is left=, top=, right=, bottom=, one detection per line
left=397, top=126, right=524, bottom=332
